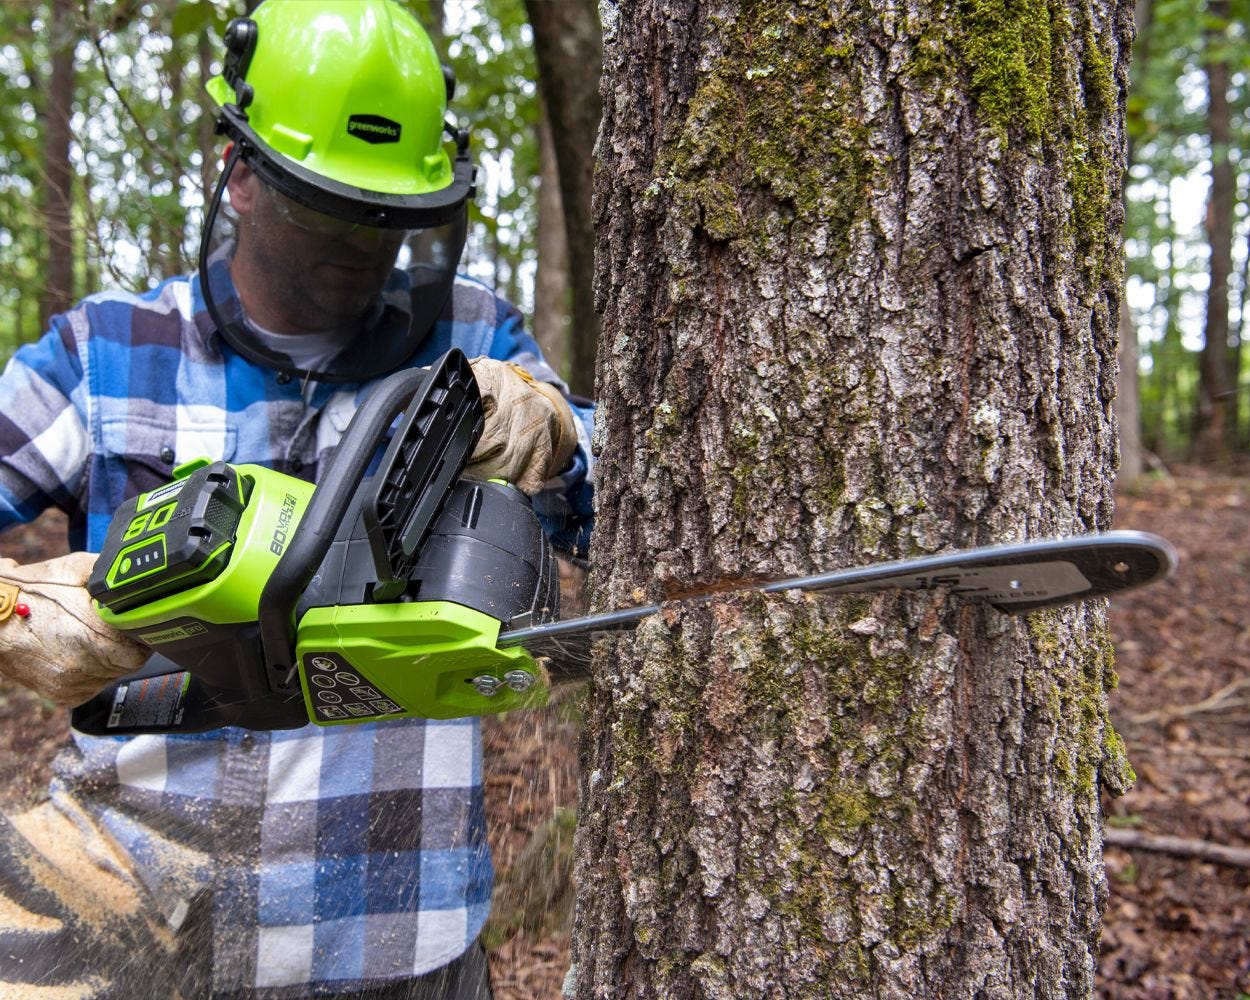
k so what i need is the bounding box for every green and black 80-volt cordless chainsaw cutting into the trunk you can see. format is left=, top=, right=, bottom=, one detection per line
left=73, top=350, right=1176, bottom=735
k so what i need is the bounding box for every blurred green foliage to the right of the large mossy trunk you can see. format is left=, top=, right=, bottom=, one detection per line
left=1125, top=0, right=1250, bottom=456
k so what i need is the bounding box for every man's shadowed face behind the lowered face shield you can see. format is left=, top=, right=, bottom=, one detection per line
left=229, top=164, right=405, bottom=333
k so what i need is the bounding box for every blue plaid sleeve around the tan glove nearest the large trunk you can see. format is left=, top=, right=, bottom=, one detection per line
left=489, top=299, right=595, bottom=559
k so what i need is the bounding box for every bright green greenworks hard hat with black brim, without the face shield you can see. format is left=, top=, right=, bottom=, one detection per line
left=208, top=0, right=473, bottom=229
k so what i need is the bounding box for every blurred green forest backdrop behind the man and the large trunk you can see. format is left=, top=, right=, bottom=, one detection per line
left=0, top=0, right=1250, bottom=465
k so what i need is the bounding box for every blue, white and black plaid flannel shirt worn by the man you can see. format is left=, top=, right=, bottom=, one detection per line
left=0, top=270, right=593, bottom=996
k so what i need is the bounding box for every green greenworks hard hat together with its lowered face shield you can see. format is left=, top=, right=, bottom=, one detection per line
left=199, top=0, right=475, bottom=383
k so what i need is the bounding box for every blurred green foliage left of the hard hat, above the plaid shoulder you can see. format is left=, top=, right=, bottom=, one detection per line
left=0, top=0, right=245, bottom=356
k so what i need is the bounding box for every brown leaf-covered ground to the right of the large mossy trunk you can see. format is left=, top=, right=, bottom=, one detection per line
left=1099, top=469, right=1250, bottom=1000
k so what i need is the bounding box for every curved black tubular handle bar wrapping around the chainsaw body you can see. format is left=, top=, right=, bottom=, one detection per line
left=258, top=349, right=469, bottom=691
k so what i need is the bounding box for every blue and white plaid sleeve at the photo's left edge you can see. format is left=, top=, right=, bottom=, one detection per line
left=0, top=315, right=90, bottom=530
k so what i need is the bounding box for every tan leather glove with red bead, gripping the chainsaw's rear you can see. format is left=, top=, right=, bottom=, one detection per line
left=0, top=553, right=151, bottom=705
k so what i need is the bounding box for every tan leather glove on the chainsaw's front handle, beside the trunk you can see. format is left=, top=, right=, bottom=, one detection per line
left=465, top=358, right=578, bottom=496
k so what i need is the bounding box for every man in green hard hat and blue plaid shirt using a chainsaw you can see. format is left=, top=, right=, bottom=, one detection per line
left=0, top=0, right=591, bottom=999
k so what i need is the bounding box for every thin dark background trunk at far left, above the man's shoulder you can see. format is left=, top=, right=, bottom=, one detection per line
left=39, top=0, right=78, bottom=328
